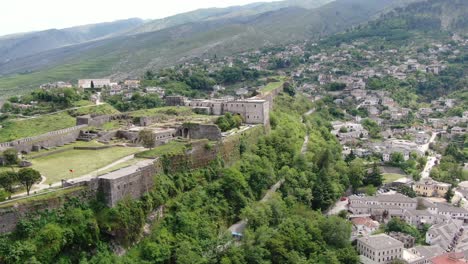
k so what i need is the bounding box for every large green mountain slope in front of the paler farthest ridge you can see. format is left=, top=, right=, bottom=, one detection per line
left=0, top=0, right=450, bottom=95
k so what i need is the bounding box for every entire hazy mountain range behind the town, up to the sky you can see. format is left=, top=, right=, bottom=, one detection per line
left=0, top=0, right=466, bottom=94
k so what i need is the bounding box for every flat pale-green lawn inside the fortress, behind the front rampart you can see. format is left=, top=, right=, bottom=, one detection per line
left=31, top=147, right=141, bottom=184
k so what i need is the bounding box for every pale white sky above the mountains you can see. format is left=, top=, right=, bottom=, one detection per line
left=0, top=0, right=278, bottom=35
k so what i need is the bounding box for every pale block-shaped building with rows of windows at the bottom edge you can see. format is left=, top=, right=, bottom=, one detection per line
left=357, top=234, right=403, bottom=263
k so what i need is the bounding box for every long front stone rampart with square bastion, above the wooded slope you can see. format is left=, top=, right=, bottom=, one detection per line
left=0, top=125, right=265, bottom=233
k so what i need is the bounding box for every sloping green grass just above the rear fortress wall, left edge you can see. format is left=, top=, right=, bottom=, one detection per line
left=0, top=112, right=76, bottom=142
